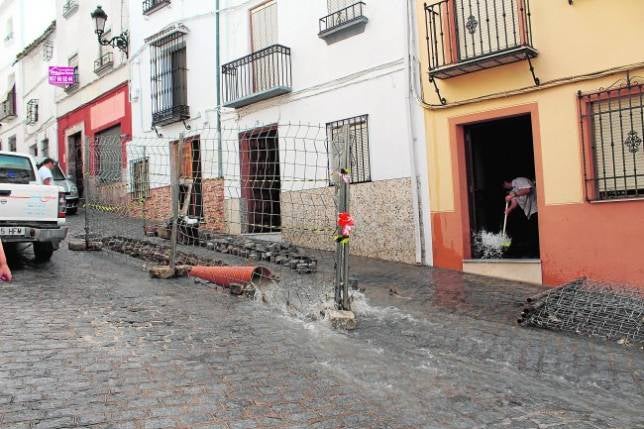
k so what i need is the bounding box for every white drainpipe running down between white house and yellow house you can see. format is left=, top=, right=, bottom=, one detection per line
left=403, top=1, right=431, bottom=264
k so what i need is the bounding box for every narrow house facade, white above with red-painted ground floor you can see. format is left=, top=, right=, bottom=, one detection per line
left=54, top=0, right=131, bottom=195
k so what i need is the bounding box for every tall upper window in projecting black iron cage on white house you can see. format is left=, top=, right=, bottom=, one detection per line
left=150, top=32, right=190, bottom=125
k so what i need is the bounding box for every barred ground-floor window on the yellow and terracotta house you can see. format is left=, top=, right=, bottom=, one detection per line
left=580, top=80, right=644, bottom=200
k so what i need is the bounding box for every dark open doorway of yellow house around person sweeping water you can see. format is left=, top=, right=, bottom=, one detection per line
left=465, top=115, right=540, bottom=259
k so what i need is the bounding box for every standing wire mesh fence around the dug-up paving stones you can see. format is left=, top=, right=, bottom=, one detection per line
left=83, top=125, right=358, bottom=315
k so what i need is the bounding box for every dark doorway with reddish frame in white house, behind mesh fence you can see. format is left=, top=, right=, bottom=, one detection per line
left=240, top=127, right=281, bottom=234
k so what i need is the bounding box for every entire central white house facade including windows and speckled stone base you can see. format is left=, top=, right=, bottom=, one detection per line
left=130, top=0, right=431, bottom=264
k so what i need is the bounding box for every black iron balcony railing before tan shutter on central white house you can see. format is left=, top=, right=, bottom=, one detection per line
left=221, top=45, right=292, bottom=108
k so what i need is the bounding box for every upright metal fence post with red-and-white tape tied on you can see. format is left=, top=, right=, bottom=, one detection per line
left=332, top=125, right=351, bottom=310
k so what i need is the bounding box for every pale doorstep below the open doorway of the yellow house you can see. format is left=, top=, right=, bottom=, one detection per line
left=463, top=259, right=543, bottom=285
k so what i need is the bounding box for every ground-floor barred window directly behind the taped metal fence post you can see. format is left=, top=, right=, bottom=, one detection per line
left=326, top=115, right=371, bottom=183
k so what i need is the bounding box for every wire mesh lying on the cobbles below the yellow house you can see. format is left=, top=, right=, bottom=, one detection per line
left=519, top=279, right=644, bottom=343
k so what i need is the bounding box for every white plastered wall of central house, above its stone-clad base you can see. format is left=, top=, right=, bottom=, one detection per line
left=130, top=0, right=431, bottom=262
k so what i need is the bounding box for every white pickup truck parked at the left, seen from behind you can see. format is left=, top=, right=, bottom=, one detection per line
left=0, top=152, right=67, bottom=262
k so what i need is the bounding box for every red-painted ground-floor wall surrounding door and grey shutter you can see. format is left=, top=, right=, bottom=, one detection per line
left=58, top=82, right=132, bottom=171
